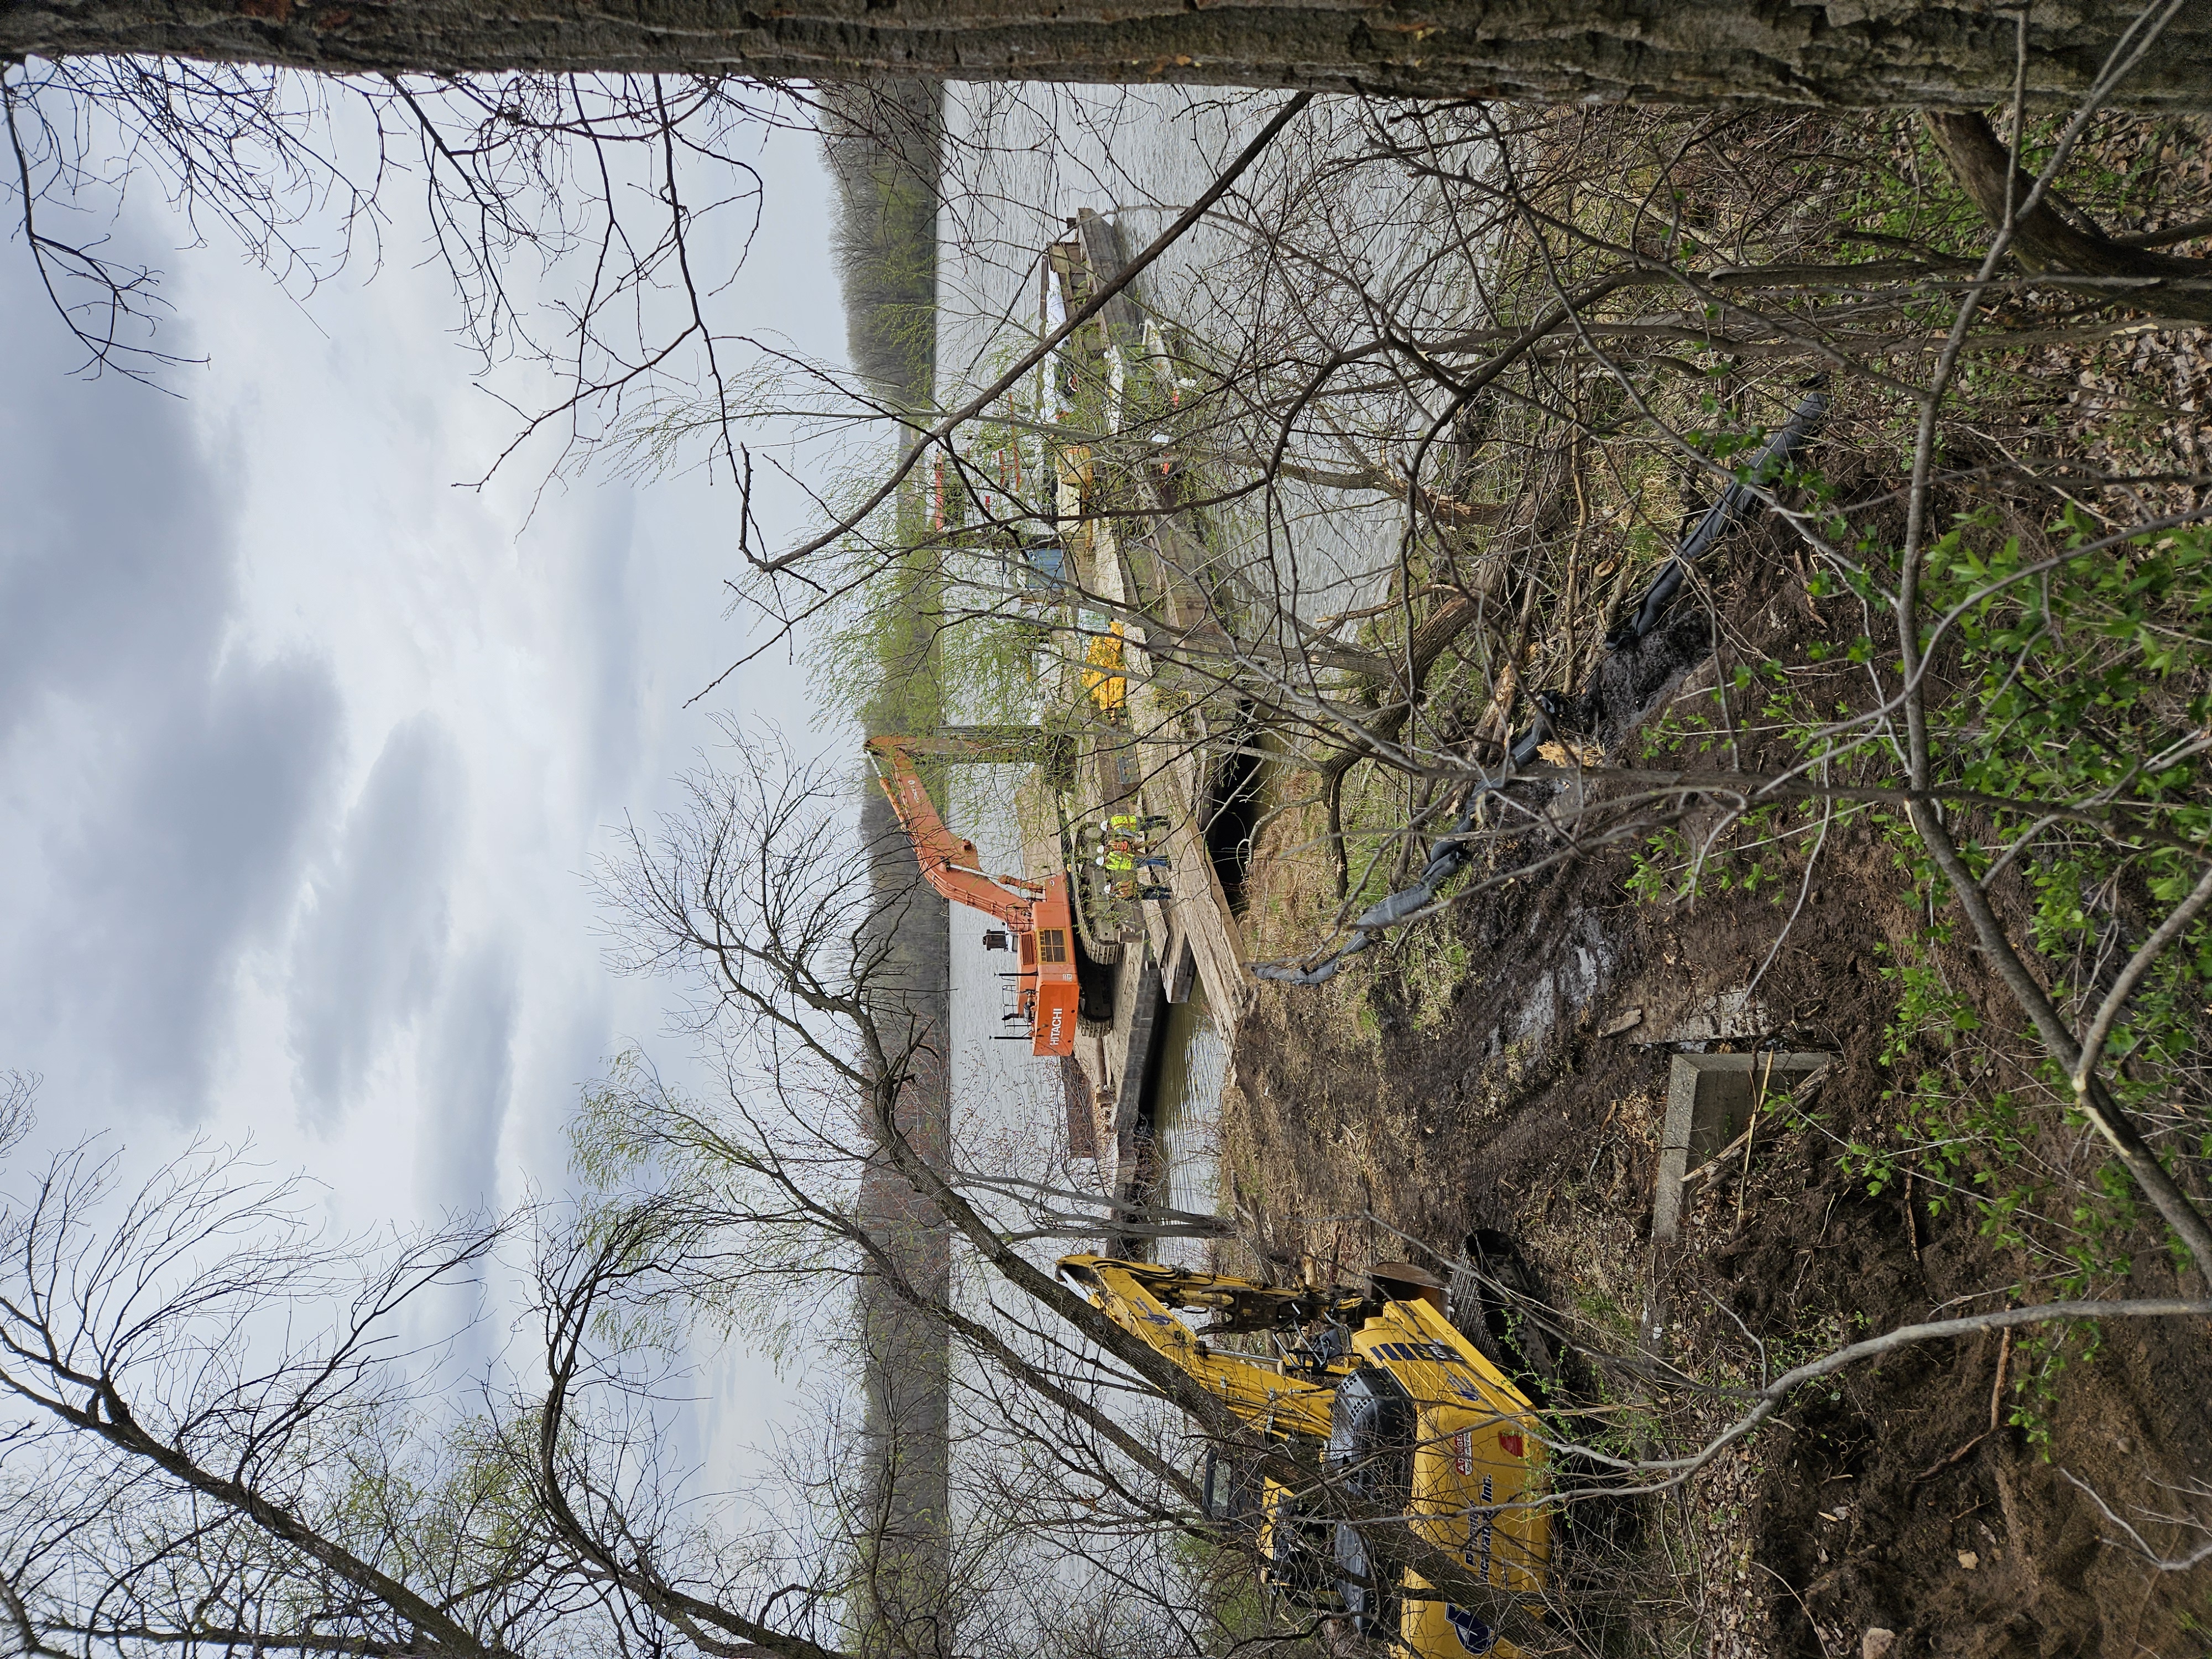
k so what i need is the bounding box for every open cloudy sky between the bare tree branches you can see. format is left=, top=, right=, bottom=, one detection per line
left=0, top=101, right=843, bottom=1469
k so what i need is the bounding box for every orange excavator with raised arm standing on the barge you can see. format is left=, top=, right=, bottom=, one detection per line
left=867, top=737, right=1113, bottom=1055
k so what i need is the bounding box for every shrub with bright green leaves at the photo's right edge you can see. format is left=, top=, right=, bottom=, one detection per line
left=1630, top=509, right=2212, bottom=1389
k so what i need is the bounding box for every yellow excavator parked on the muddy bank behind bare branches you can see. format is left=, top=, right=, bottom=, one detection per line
left=1060, top=1256, right=1551, bottom=1659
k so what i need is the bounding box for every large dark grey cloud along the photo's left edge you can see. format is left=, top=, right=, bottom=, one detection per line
left=0, top=259, right=341, bottom=1119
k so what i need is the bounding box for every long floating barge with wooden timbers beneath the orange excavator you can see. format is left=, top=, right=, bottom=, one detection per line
left=1024, top=210, right=1252, bottom=1199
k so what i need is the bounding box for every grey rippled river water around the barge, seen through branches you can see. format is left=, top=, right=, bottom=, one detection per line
left=938, top=84, right=1449, bottom=1265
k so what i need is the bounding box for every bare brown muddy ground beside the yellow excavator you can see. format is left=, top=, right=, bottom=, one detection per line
left=1223, top=538, right=2212, bottom=1659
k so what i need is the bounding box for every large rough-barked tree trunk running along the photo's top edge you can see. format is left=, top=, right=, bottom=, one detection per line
left=13, top=0, right=2212, bottom=111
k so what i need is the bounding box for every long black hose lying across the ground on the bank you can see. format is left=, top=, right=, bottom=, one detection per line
left=1252, top=380, right=1827, bottom=984
